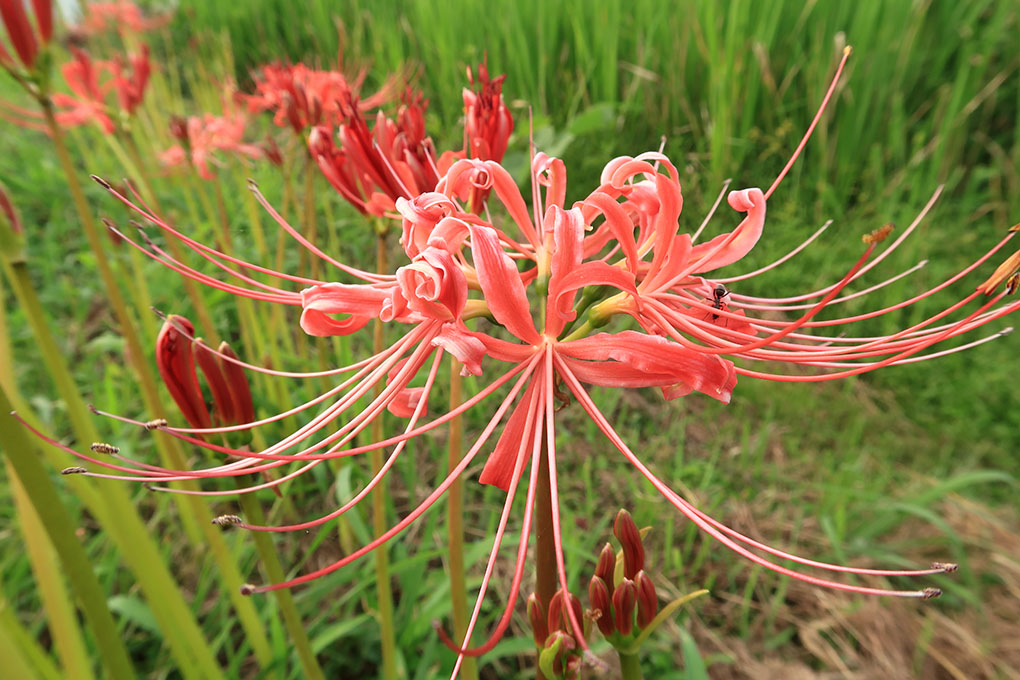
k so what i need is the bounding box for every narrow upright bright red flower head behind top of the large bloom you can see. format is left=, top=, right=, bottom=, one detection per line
left=464, top=59, right=513, bottom=162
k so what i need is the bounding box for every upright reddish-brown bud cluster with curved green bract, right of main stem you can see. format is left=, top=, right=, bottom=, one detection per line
left=588, top=510, right=707, bottom=653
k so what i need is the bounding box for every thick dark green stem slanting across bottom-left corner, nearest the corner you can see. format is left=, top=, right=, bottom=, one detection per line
left=0, top=390, right=135, bottom=678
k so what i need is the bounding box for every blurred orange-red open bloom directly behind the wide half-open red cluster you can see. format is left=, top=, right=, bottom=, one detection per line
left=246, top=63, right=397, bottom=135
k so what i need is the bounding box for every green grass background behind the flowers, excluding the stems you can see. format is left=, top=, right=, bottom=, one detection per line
left=0, top=0, right=1020, bottom=678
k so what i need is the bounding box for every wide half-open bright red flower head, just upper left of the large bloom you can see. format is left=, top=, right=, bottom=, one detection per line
left=308, top=91, right=440, bottom=216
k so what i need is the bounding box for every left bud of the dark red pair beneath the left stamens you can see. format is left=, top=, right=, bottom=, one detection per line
left=156, top=315, right=212, bottom=427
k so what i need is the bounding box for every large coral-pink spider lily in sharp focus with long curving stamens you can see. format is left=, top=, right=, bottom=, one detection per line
left=19, top=47, right=1020, bottom=674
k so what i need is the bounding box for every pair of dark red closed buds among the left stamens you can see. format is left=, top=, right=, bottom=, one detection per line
left=156, top=315, right=255, bottom=427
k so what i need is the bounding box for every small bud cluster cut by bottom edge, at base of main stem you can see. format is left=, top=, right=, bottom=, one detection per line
left=527, top=589, right=589, bottom=680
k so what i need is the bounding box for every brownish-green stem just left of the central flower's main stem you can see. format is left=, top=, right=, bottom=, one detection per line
left=447, top=367, right=478, bottom=680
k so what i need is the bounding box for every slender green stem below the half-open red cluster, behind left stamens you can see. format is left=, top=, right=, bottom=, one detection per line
left=369, top=230, right=397, bottom=680
